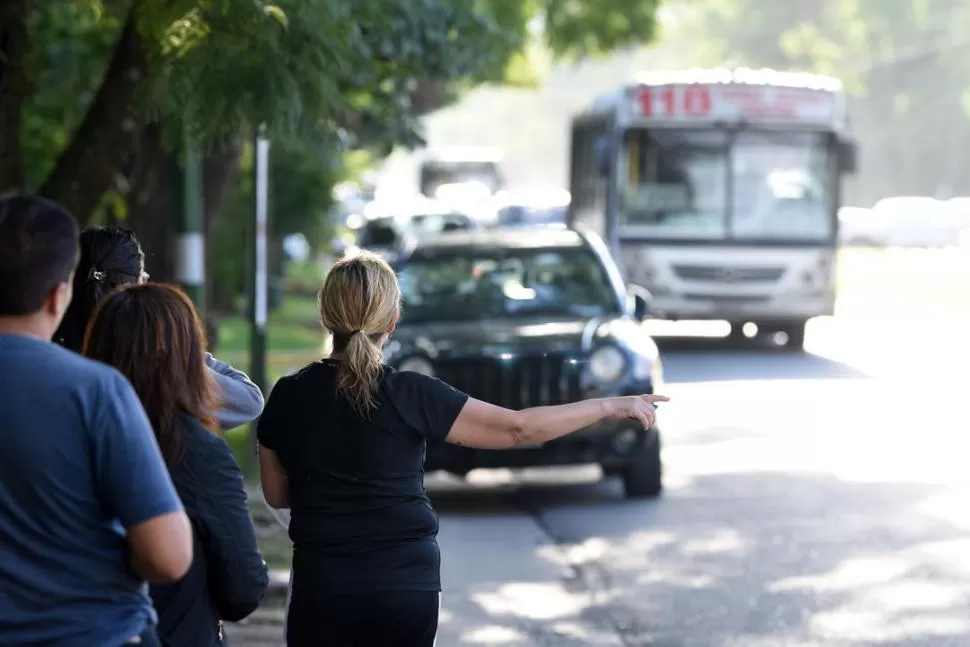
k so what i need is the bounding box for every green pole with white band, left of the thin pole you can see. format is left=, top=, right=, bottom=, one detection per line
left=175, top=137, right=205, bottom=318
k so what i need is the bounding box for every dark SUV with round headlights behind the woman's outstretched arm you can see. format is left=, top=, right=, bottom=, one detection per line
left=384, top=229, right=663, bottom=497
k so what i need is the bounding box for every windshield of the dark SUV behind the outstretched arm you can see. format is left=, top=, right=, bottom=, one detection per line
left=397, top=247, right=619, bottom=323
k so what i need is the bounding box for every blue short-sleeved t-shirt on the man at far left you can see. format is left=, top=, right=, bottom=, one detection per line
left=0, top=334, right=182, bottom=647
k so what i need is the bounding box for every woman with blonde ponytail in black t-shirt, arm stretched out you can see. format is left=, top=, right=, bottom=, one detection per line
left=257, top=253, right=667, bottom=647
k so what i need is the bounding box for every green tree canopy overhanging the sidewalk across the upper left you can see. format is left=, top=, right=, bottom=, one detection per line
left=9, top=0, right=672, bottom=312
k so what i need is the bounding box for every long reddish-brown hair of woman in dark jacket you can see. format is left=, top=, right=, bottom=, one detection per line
left=84, top=283, right=218, bottom=465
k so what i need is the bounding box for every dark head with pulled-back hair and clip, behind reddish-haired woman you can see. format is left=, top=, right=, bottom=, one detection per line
left=54, top=227, right=148, bottom=352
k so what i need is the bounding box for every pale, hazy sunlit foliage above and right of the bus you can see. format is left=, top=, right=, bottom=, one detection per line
left=670, top=0, right=970, bottom=203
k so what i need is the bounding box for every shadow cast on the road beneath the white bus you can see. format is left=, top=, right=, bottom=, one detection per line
left=655, top=337, right=870, bottom=383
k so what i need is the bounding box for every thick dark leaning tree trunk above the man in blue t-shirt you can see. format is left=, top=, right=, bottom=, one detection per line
left=38, top=8, right=147, bottom=223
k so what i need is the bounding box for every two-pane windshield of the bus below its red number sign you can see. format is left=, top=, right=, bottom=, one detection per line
left=617, top=129, right=835, bottom=242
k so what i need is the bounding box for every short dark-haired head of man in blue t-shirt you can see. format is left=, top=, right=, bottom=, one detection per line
left=0, top=195, right=78, bottom=339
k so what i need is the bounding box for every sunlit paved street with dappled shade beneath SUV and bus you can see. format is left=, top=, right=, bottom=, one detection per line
left=234, top=306, right=970, bottom=647
